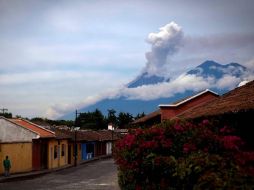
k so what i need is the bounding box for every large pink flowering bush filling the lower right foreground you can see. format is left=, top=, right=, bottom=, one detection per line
left=114, top=120, right=254, bottom=190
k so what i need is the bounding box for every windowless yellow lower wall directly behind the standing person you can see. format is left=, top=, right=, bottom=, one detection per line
left=0, top=142, right=32, bottom=174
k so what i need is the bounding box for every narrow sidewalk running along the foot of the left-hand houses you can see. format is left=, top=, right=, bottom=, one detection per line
left=0, top=155, right=112, bottom=183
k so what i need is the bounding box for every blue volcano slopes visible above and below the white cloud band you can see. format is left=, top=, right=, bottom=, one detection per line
left=61, top=61, right=250, bottom=119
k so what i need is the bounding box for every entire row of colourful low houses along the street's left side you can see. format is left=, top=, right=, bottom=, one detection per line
left=0, top=117, right=118, bottom=173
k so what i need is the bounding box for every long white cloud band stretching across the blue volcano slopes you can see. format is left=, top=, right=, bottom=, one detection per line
left=48, top=62, right=254, bottom=117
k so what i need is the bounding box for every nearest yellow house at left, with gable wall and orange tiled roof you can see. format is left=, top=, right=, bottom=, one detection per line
left=0, top=117, right=68, bottom=173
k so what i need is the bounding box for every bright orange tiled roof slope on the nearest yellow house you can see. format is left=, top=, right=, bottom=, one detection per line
left=10, top=119, right=55, bottom=138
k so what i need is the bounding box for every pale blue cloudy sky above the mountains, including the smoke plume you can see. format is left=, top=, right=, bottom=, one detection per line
left=0, top=0, right=254, bottom=119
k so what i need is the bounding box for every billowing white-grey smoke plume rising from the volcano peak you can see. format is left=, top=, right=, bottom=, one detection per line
left=144, top=22, right=183, bottom=76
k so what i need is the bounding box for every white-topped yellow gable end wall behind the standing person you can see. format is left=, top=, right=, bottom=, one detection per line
left=0, top=117, right=38, bottom=173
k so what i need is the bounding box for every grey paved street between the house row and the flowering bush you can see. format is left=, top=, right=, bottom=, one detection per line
left=0, top=159, right=120, bottom=190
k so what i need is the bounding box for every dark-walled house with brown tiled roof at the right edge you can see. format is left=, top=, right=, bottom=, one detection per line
left=176, top=81, right=254, bottom=149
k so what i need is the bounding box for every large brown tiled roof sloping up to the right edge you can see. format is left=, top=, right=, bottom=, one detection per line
left=178, top=81, right=254, bottom=118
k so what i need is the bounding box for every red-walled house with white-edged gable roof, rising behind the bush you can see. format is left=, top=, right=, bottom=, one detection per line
left=132, top=89, right=219, bottom=127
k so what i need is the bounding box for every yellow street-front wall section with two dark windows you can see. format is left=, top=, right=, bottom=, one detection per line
left=48, top=139, right=68, bottom=169
